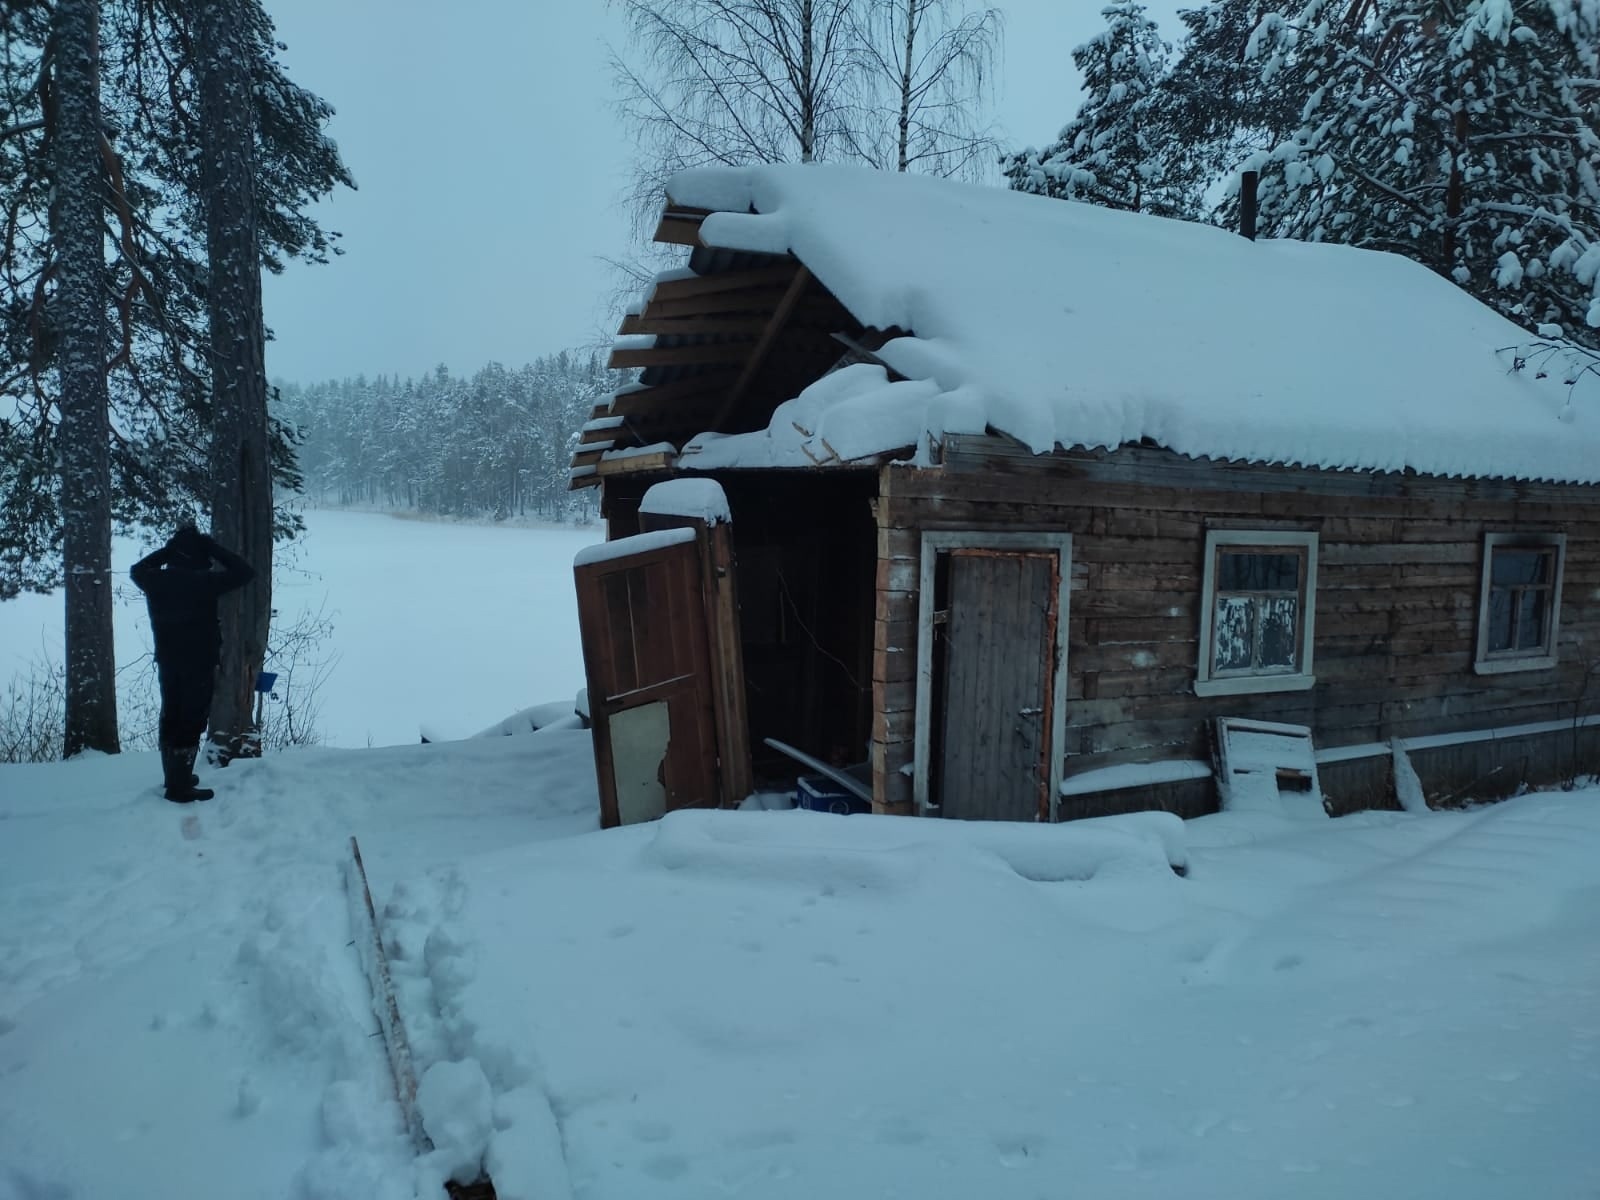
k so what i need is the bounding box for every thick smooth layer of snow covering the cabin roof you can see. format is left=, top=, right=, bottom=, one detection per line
left=667, top=165, right=1600, bottom=483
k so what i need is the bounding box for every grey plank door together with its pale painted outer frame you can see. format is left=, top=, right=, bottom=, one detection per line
left=915, top=533, right=1070, bottom=821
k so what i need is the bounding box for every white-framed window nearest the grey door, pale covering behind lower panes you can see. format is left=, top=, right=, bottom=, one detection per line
left=1195, top=530, right=1317, bottom=696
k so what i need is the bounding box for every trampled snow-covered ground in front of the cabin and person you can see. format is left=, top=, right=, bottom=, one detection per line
left=0, top=730, right=1600, bottom=1200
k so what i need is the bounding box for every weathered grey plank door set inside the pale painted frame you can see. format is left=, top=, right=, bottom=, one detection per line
left=934, top=549, right=1061, bottom=821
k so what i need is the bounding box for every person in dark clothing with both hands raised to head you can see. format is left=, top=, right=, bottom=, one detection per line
left=133, top=525, right=256, bottom=803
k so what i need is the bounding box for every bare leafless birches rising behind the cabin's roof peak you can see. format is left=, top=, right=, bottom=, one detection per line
left=613, top=0, right=1000, bottom=232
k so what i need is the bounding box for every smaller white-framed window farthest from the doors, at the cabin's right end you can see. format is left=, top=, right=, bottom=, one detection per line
left=1475, top=533, right=1566, bottom=674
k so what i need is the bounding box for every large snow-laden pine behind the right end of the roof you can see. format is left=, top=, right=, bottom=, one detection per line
left=1251, top=0, right=1600, bottom=347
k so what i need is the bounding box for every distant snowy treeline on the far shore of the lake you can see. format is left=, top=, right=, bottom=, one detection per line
left=274, top=352, right=616, bottom=520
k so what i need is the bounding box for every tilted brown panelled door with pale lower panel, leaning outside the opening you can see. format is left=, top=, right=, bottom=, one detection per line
left=574, top=530, right=718, bottom=829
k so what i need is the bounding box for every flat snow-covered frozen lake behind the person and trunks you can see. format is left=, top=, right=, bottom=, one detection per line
left=0, top=510, right=605, bottom=746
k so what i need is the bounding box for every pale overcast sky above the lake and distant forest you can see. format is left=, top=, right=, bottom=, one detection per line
left=266, top=0, right=1189, bottom=382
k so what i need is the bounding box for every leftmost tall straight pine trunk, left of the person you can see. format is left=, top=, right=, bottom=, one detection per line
left=50, top=0, right=120, bottom=757
